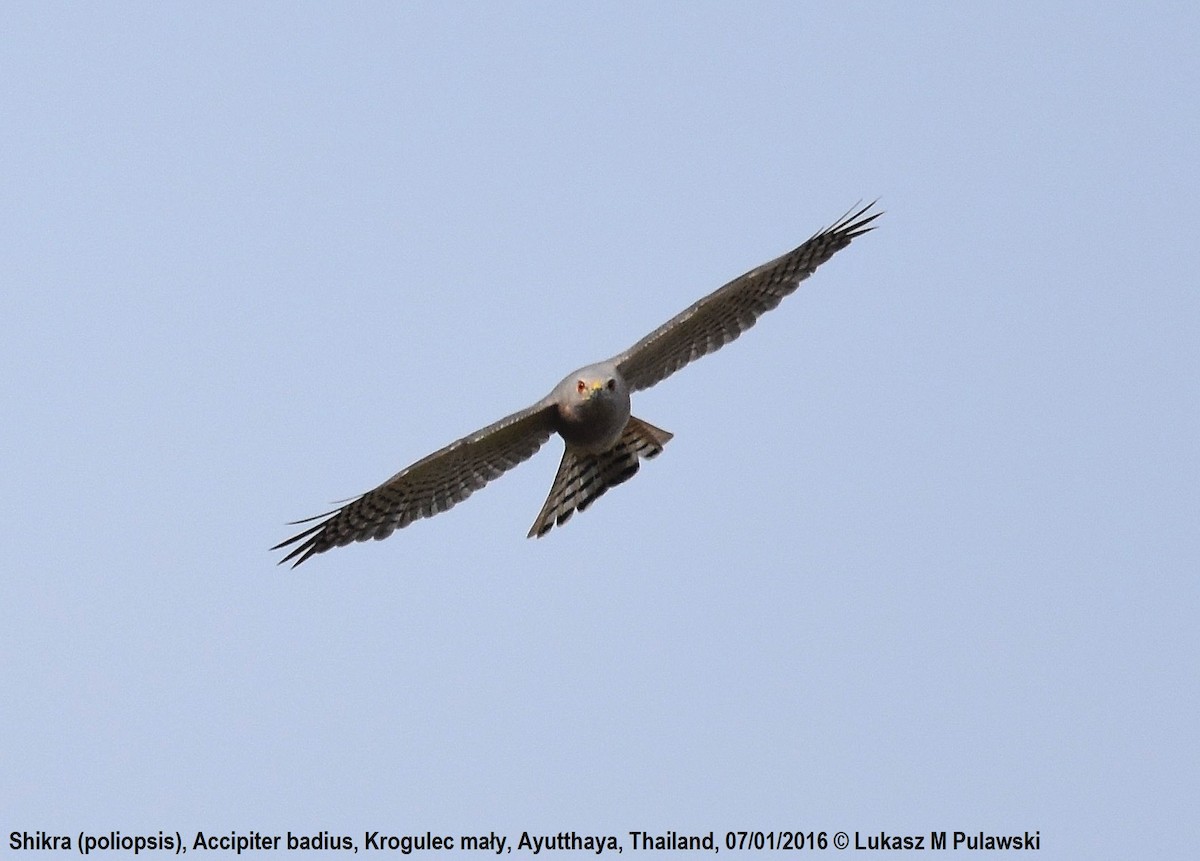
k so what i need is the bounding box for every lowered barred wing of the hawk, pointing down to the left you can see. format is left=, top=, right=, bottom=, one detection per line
left=271, top=399, right=556, bottom=567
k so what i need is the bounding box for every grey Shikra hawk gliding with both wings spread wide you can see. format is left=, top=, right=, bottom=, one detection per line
left=271, top=204, right=882, bottom=567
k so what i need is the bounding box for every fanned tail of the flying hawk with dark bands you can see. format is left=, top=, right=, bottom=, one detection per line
left=528, top=416, right=673, bottom=538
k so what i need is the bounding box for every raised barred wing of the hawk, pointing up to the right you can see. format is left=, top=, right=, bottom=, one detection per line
left=612, top=203, right=883, bottom=391
